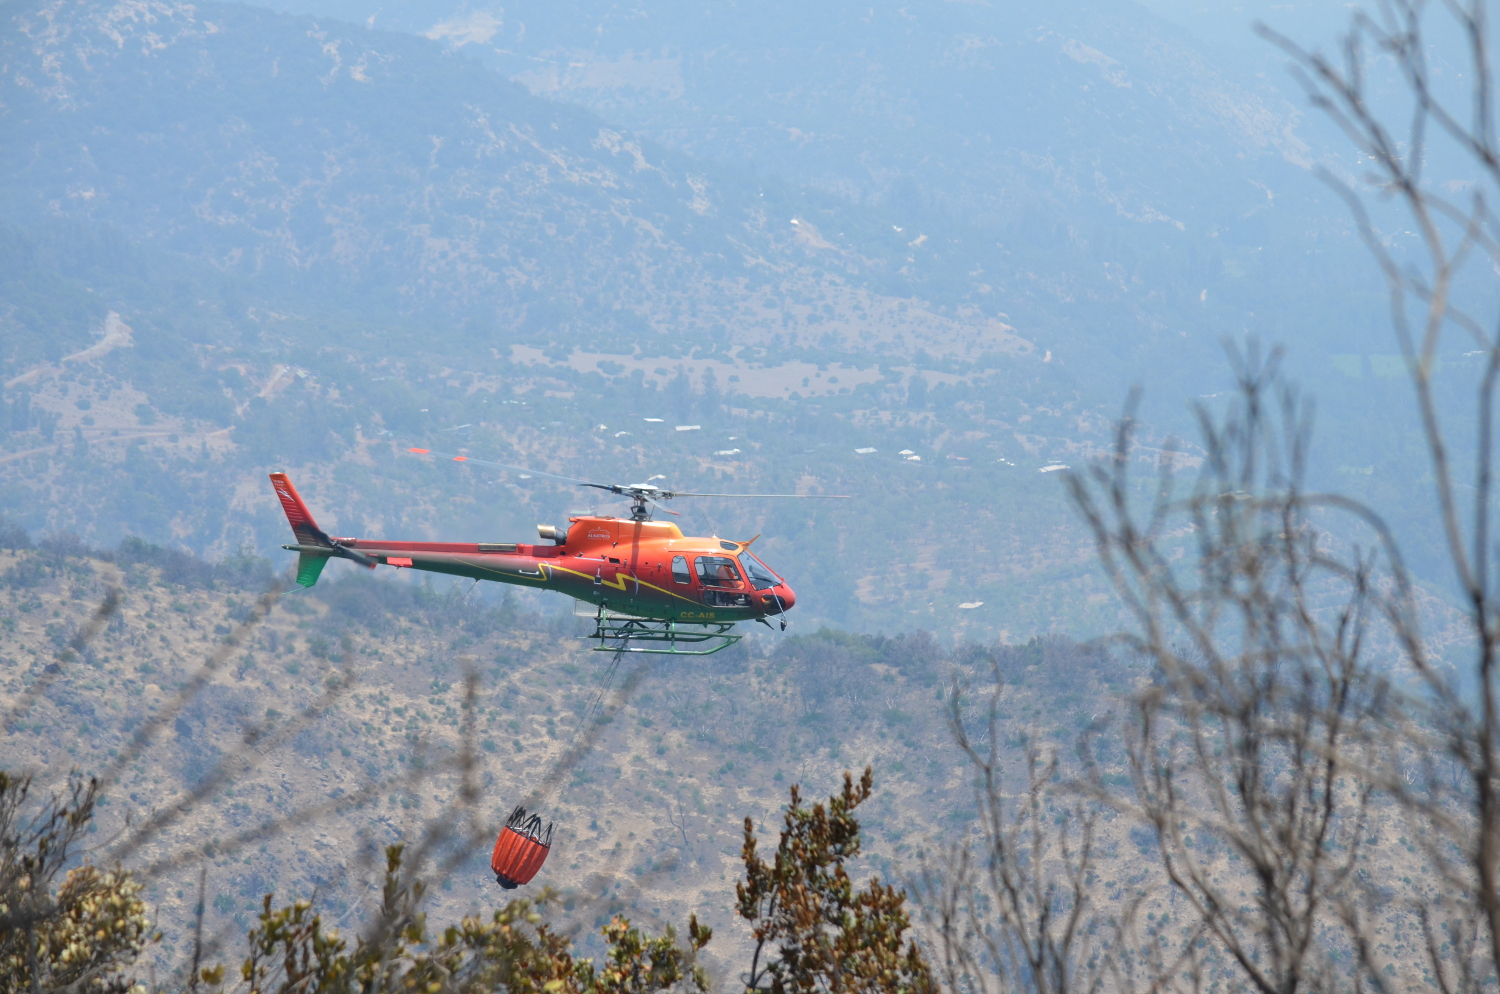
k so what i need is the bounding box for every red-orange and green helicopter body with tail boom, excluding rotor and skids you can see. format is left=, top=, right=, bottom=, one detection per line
left=288, top=517, right=797, bottom=624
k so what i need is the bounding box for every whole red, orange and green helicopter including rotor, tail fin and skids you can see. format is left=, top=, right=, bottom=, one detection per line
left=270, top=461, right=849, bottom=655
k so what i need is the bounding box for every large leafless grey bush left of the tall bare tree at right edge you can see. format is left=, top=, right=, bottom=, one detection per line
left=1070, top=349, right=1398, bottom=993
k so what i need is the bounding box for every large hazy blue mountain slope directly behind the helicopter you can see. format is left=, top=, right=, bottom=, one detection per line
left=0, top=3, right=1452, bottom=639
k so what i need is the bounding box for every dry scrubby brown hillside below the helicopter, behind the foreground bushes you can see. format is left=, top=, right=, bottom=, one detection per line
left=0, top=550, right=1440, bottom=978
